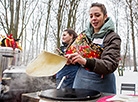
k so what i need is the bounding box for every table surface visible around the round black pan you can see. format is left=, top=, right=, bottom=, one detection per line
left=21, top=92, right=114, bottom=102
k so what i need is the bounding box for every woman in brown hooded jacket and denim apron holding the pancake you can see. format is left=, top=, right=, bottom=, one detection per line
left=65, top=3, right=121, bottom=93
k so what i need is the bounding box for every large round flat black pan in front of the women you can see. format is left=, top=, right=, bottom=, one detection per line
left=39, top=88, right=101, bottom=101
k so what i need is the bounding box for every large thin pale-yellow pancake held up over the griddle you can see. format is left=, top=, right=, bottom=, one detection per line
left=26, top=51, right=67, bottom=77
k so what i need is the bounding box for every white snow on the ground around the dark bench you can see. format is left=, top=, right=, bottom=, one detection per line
left=115, top=68, right=138, bottom=95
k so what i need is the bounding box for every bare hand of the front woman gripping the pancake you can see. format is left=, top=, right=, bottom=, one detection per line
left=65, top=53, right=86, bottom=65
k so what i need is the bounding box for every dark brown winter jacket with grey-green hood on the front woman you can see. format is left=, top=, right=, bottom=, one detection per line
left=85, top=17, right=121, bottom=75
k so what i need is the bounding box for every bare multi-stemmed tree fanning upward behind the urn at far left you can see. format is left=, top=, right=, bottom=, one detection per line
left=0, top=0, right=39, bottom=38
